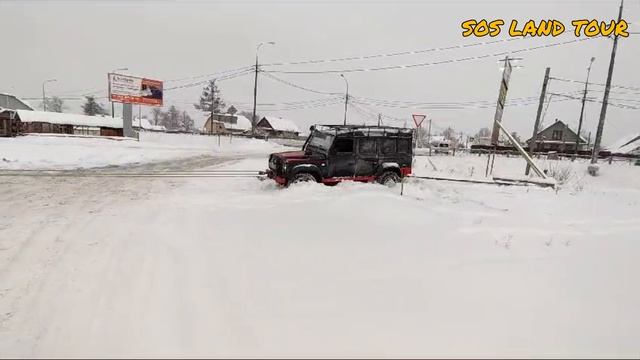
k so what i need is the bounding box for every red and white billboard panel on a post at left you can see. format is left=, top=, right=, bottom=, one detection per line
left=109, top=73, right=163, bottom=106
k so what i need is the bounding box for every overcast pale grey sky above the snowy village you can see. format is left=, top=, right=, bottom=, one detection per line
left=0, top=0, right=640, bottom=144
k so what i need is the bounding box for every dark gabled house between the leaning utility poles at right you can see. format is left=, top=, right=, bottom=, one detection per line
left=526, top=119, right=587, bottom=152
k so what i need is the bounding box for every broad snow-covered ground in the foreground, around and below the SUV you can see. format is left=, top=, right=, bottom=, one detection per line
left=0, top=156, right=640, bottom=358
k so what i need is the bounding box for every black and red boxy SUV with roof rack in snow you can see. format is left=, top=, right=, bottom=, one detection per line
left=267, top=125, right=413, bottom=186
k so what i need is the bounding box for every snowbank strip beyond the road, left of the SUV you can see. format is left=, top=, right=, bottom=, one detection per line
left=0, top=132, right=282, bottom=170
